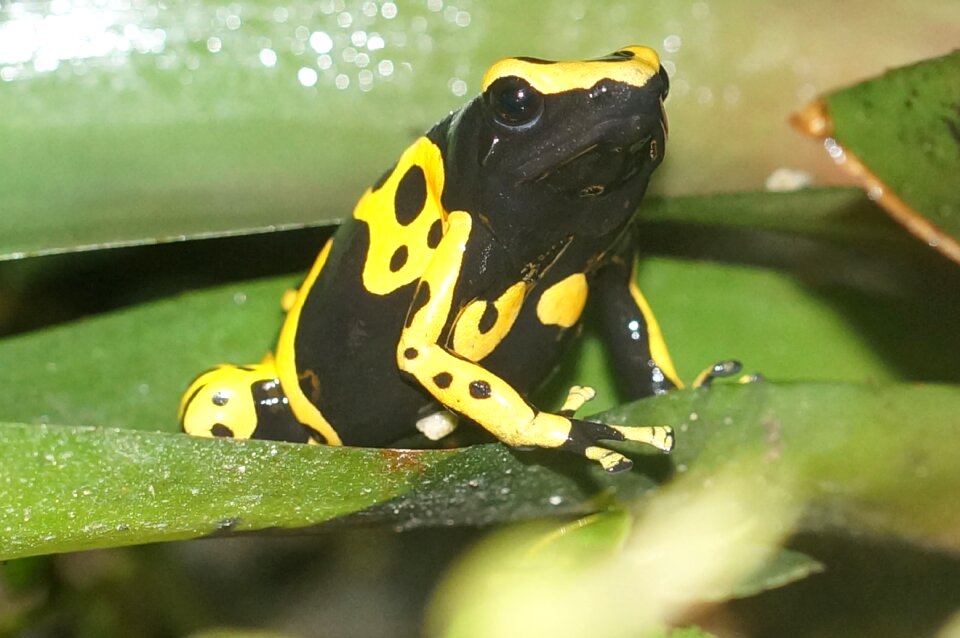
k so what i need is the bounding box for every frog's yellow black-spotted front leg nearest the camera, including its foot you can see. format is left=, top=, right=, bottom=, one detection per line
left=397, top=211, right=673, bottom=472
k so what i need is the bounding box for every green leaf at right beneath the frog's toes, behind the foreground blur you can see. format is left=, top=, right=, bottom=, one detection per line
left=610, top=382, right=960, bottom=549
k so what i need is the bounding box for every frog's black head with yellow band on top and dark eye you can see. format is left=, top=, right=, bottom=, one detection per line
left=442, top=46, right=669, bottom=238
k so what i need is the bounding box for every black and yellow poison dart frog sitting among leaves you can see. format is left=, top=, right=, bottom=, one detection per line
left=180, top=46, right=728, bottom=472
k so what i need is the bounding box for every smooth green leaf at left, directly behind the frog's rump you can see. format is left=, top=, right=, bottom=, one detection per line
left=0, top=277, right=298, bottom=431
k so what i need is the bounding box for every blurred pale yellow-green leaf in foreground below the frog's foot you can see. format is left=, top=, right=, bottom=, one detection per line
left=428, top=472, right=797, bottom=638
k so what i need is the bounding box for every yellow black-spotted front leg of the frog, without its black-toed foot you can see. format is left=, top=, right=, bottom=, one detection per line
left=397, top=211, right=571, bottom=447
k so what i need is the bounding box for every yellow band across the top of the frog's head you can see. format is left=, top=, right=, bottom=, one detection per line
left=482, top=46, right=660, bottom=95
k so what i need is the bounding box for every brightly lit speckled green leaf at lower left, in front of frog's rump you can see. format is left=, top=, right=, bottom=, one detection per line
left=0, top=424, right=444, bottom=560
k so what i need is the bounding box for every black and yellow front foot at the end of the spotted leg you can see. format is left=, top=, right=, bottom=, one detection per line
left=562, top=419, right=673, bottom=474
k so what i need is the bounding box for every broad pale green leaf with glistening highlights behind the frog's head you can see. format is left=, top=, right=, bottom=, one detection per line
left=0, top=0, right=958, bottom=258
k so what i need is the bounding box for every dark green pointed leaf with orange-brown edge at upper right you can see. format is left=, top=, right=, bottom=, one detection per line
left=796, top=52, right=960, bottom=261
